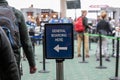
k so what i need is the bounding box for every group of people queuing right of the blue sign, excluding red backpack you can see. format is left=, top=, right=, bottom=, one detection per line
left=77, top=10, right=120, bottom=62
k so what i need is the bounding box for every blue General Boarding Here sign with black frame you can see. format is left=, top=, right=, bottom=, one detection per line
left=45, top=23, right=74, bottom=59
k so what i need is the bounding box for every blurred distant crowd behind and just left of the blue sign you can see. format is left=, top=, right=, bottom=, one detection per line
left=26, top=15, right=73, bottom=45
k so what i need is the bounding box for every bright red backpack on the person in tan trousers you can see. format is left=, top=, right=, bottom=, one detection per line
left=74, top=17, right=85, bottom=32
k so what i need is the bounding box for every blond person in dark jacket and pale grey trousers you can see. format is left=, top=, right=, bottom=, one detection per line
left=96, top=11, right=112, bottom=61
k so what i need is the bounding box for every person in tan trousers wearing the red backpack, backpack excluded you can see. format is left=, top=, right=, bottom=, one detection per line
left=77, top=10, right=92, bottom=58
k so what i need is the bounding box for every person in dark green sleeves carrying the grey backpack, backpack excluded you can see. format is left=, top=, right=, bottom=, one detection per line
left=0, top=0, right=36, bottom=78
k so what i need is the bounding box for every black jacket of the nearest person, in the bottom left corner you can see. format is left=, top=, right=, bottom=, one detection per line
left=0, top=27, right=20, bottom=80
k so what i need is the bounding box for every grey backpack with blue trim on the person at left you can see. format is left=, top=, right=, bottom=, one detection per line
left=0, top=6, right=21, bottom=49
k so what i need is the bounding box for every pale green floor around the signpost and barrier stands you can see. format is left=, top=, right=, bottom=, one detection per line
left=22, top=41, right=120, bottom=80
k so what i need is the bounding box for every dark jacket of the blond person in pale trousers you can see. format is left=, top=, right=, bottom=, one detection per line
left=97, top=19, right=112, bottom=35
